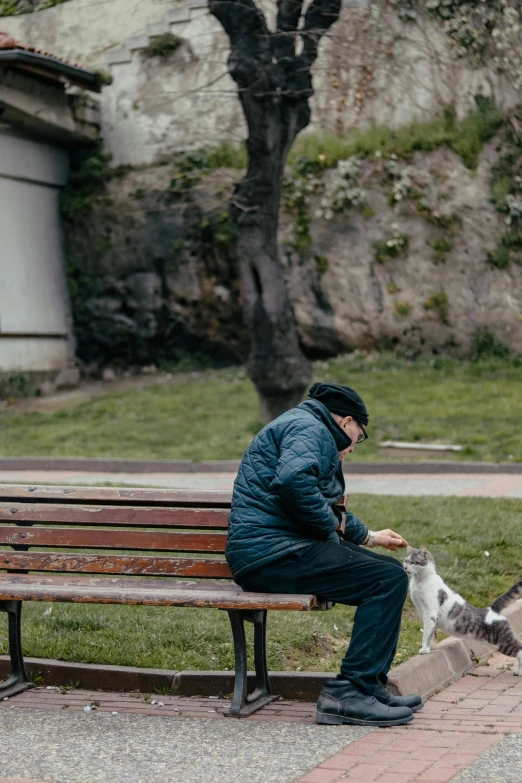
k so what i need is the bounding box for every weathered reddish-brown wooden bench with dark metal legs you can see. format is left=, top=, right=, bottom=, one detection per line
left=0, top=485, right=331, bottom=717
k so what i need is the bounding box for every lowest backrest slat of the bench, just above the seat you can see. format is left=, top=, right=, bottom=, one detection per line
left=0, top=552, right=232, bottom=579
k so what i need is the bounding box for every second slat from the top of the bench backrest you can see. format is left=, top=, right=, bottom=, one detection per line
left=0, top=502, right=228, bottom=530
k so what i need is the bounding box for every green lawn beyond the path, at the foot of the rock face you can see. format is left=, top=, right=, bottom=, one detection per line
left=0, top=354, right=522, bottom=461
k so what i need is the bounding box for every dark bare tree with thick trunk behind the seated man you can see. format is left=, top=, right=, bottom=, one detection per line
left=209, top=0, right=341, bottom=421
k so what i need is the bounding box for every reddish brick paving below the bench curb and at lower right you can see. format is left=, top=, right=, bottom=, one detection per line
left=0, top=654, right=522, bottom=783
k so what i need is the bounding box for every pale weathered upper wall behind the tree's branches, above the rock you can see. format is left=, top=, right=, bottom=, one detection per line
left=1, top=0, right=518, bottom=165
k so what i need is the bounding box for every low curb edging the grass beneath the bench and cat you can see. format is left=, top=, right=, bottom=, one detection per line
left=5, top=599, right=522, bottom=701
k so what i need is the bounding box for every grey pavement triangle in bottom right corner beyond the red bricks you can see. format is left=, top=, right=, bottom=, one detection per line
left=452, top=734, right=522, bottom=783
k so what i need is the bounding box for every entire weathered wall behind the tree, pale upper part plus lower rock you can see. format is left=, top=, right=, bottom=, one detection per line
left=1, top=0, right=522, bottom=363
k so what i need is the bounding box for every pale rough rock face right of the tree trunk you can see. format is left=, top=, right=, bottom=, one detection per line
left=284, top=144, right=522, bottom=356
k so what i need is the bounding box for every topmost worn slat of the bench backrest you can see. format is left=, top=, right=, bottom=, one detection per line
left=0, top=484, right=232, bottom=509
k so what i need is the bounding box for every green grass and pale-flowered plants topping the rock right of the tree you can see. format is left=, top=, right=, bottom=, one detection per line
left=282, top=95, right=502, bottom=263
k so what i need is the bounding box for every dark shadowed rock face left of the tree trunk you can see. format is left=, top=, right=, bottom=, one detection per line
left=66, top=165, right=248, bottom=364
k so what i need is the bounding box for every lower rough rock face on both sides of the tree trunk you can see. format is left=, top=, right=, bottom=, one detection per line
left=67, top=141, right=522, bottom=364
